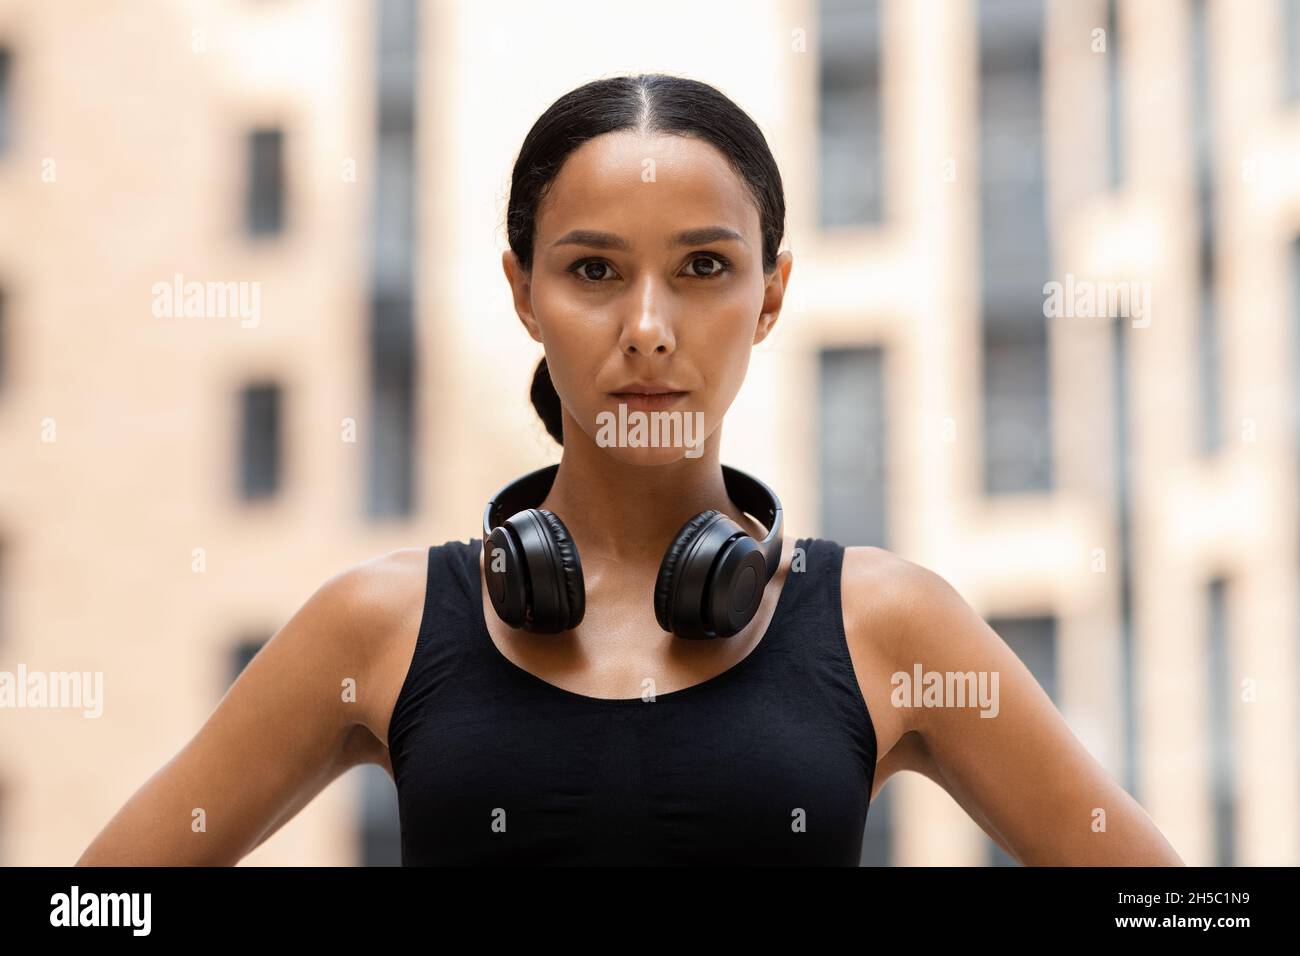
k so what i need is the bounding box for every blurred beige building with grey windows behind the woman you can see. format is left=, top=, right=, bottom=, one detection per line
left=0, top=0, right=1300, bottom=865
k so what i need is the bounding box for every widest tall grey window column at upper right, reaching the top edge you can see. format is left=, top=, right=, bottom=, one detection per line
left=978, top=0, right=1052, bottom=494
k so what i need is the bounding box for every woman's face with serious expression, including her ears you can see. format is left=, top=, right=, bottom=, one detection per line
left=503, top=133, right=790, bottom=464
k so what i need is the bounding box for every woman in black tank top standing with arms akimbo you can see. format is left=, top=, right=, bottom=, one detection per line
left=79, top=74, right=1182, bottom=865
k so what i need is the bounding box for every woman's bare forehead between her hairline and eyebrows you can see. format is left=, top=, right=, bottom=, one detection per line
left=537, top=131, right=761, bottom=247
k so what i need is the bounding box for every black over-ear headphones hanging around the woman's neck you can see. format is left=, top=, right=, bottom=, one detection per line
left=482, top=464, right=781, bottom=639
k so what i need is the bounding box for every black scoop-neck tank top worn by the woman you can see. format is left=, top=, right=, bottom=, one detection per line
left=389, top=538, right=876, bottom=866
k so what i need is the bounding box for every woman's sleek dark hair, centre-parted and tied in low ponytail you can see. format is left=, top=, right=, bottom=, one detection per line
left=506, top=73, right=785, bottom=445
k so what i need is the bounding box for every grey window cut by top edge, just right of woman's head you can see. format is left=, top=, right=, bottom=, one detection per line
left=818, top=0, right=884, bottom=228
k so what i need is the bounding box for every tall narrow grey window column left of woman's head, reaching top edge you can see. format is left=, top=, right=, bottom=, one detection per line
left=367, top=0, right=419, bottom=518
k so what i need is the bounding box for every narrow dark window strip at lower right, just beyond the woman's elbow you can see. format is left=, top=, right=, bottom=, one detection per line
left=1205, top=578, right=1236, bottom=866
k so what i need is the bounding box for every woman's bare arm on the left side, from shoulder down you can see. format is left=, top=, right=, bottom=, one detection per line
left=77, top=546, right=410, bottom=866
